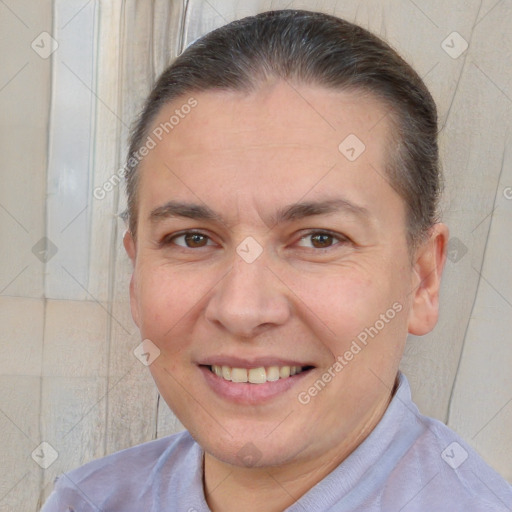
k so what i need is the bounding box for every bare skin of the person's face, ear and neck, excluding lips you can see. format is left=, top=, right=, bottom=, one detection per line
left=124, top=81, right=448, bottom=512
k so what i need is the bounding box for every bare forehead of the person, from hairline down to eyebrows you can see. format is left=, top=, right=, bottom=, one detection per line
left=139, top=81, right=400, bottom=226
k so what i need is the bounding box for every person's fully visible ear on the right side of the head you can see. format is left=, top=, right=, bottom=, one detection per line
left=408, top=223, right=449, bottom=336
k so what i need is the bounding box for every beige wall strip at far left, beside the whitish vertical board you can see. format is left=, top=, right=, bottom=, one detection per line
left=0, top=1, right=52, bottom=511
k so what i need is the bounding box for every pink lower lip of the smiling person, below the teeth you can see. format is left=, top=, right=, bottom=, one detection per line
left=199, top=366, right=311, bottom=405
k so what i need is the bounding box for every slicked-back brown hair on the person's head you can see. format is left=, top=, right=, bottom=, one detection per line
left=126, top=10, right=441, bottom=247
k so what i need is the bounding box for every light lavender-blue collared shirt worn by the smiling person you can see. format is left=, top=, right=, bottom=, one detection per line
left=42, top=374, right=512, bottom=512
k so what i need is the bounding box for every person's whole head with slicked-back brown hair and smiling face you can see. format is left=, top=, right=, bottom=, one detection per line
left=125, top=11, right=447, bottom=466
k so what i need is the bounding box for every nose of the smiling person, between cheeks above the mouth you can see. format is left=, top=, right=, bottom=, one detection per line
left=205, top=250, right=290, bottom=338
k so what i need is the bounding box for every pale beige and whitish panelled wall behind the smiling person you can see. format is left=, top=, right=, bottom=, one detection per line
left=0, top=0, right=512, bottom=512
